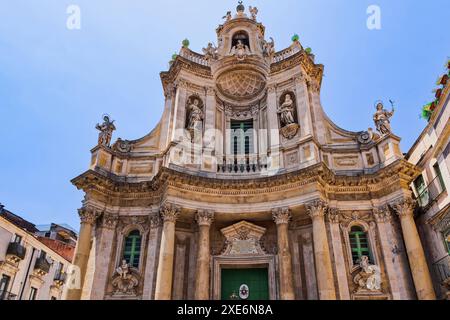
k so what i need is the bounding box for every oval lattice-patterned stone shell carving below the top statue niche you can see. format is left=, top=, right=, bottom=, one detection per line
left=217, top=70, right=265, bottom=99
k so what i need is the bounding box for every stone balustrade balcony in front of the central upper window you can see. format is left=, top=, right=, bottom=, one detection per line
left=217, top=155, right=267, bottom=175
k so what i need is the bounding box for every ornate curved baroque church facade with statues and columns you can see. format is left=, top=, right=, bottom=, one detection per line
left=67, top=4, right=435, bottom=300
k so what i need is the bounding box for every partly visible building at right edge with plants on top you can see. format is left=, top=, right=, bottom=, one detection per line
left=406, top=63, right=450, bottom=299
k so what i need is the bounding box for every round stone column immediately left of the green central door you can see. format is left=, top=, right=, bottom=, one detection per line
left=194, top=211, right=214, bottom=300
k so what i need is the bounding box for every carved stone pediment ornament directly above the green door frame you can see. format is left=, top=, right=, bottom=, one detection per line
left=220, top=221, right=266, bottom=256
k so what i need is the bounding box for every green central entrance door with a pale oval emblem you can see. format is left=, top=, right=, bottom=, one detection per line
left=221, top=268, right=269, bottom=300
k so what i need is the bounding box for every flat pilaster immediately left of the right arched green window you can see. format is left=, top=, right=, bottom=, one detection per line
left=328, top=208, right=350, bottom=300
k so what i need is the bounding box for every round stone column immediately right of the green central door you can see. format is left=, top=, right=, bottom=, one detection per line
left=272, top=208, right=295, bottom=300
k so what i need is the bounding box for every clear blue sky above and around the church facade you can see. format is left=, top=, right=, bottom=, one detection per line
left=0, top=0, right=450, bottom=228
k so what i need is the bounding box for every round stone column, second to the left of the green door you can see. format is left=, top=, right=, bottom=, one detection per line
left=155, top=204, right=180, bottom=300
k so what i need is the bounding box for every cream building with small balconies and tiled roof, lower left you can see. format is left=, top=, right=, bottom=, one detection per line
left=0, top=205, right=77, bottom=300
